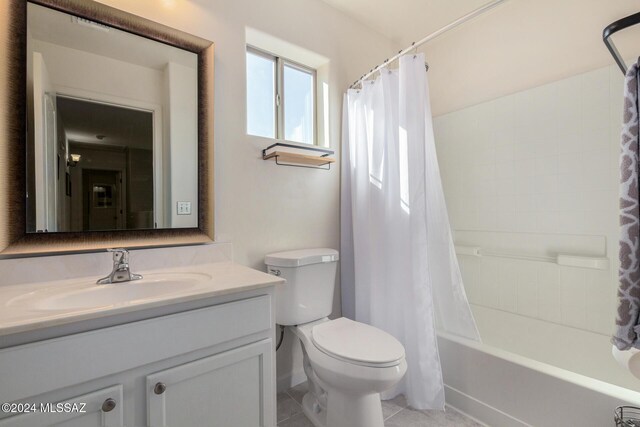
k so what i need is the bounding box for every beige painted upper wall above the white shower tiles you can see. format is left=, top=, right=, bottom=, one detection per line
left=422, top=0, right=640, bottom=116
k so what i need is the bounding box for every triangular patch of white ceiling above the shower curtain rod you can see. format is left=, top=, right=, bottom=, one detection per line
left=324, top=0, right=489, bottom=48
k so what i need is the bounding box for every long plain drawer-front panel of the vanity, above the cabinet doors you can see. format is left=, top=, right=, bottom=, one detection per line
left=0, top=295, right=272, bottom=402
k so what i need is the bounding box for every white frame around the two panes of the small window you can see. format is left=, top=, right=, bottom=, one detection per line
left=245, top=45, right=318, bottom=145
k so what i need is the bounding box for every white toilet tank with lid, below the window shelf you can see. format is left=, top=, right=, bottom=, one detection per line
left=264, top=248, right=338, bottom=325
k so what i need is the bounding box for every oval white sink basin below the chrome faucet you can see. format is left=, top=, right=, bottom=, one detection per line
left=7, top=273, right=211, bottom=310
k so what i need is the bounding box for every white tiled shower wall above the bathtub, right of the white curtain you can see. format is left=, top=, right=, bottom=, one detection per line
left=434, top=66, right=623, bottom=334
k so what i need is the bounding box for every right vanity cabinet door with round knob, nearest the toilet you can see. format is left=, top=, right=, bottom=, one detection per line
left=147, top=339, right=275, bottom=427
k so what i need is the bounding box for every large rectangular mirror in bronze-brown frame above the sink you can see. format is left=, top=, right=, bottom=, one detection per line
left=0, top=0, right=213, bottom=256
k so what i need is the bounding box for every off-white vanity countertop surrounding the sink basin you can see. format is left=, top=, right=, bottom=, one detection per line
left=0, top=262, right=284, bottom=337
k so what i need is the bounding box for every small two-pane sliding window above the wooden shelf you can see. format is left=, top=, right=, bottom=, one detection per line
left=247, top=46, right=316, bottom=144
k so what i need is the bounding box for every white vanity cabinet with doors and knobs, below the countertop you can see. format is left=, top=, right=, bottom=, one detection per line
left=0, top=287, right=275, bottom=427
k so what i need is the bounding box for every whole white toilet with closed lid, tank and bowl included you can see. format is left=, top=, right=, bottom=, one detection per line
left=265, top=249, right=407, bottom=427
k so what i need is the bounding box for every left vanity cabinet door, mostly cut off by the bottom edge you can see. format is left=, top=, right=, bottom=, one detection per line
left=0, top=385, right=123, bottom=427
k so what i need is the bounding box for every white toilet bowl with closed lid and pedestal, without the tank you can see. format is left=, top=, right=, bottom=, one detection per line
left=290, top=318, right=407, bottom=427
